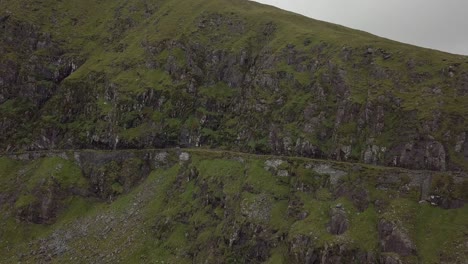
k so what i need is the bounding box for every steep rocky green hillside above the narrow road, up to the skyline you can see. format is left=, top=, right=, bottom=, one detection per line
left=0, top=0, right=468, bottom=170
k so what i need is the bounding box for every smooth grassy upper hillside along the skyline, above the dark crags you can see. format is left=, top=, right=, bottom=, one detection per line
left=6, top=0, right=466, bottom=69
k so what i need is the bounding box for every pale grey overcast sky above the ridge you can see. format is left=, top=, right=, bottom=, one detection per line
left=256, top=0, right=468, bottom=55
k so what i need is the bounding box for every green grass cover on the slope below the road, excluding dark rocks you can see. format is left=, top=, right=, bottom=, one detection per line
left=0, top=150, right=468, bottom=263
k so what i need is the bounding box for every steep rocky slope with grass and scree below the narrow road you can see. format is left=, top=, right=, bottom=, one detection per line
left=0, top=149, right=468, bottom=263
